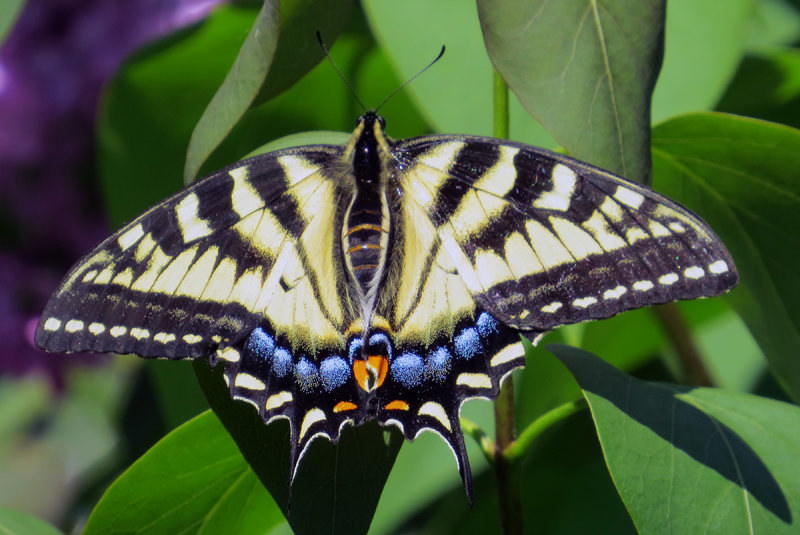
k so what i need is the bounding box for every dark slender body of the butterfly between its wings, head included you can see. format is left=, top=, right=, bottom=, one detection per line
left=342, top=112, right=392, bottom=326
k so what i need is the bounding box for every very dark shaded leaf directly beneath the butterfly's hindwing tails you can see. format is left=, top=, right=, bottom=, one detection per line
left=194, top=361, right=403, bottom=534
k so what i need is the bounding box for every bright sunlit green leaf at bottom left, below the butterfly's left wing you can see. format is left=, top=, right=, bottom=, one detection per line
left=84, top=411, right=283, bottom=535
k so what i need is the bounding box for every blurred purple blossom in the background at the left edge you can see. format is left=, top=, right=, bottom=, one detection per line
left=0, top=0, right=222, bottom=385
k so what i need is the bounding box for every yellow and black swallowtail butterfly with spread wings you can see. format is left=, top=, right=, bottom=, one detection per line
left=36, top=112, right=737, bottom=500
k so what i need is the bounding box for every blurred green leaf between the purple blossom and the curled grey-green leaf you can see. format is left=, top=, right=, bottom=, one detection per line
left=97, top=5, right=256, bottom=227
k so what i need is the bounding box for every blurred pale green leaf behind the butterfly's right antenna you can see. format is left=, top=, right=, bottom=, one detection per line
left=363, top=0, right=557, bottom=148
